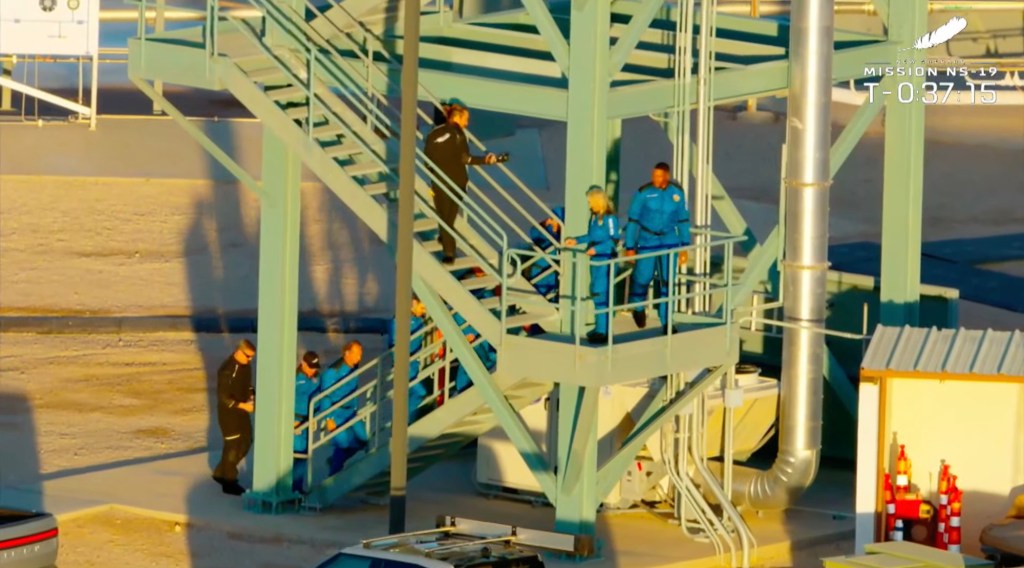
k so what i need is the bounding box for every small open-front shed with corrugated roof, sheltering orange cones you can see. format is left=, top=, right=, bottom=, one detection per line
left=856, top=325, right=1024, bottom=555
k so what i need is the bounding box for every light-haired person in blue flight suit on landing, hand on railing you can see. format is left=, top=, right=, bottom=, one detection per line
left=565, top=185, right=618, bottom=345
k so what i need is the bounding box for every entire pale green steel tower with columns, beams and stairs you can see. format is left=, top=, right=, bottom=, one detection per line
left=129, top=0, right=928, bottom=554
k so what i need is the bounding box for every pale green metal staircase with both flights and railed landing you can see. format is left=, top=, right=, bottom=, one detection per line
left=129, top=0, right=738, bottom=507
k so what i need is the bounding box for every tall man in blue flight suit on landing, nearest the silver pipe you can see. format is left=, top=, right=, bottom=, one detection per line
left=625, top=162, right=690, bottom=332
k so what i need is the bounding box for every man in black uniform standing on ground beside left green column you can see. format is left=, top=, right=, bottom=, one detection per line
left=213, top=340, right=256, bottom=495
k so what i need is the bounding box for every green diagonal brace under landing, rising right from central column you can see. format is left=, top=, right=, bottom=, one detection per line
left=597, top=363, right=732, bottom=498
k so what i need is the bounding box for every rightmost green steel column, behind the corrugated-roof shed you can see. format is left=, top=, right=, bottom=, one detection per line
left=876, top=2, right=928, bottom=325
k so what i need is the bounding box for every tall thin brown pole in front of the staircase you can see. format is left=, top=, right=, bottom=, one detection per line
left=388, top=2, right=420, bottom=534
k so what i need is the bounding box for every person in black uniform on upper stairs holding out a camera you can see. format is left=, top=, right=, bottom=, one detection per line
left=424, top=105, right=498, bottom=264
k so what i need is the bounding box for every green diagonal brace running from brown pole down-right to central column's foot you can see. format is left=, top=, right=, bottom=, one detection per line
left=413, top=275, right=556, bottom=503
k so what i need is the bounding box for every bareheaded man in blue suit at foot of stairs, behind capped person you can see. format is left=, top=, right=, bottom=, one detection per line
left=316, top=340, right=370, bottom=475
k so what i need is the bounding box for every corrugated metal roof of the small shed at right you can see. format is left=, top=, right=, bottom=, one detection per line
left=860, top=325, right=1024, bottom=377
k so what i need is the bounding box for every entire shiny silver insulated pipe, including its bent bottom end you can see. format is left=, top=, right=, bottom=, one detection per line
left=733, top=0, right=835, bottom=510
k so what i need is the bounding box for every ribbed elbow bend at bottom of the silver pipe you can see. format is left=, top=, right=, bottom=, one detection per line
left=743, top=449, right=819, bottom=511
